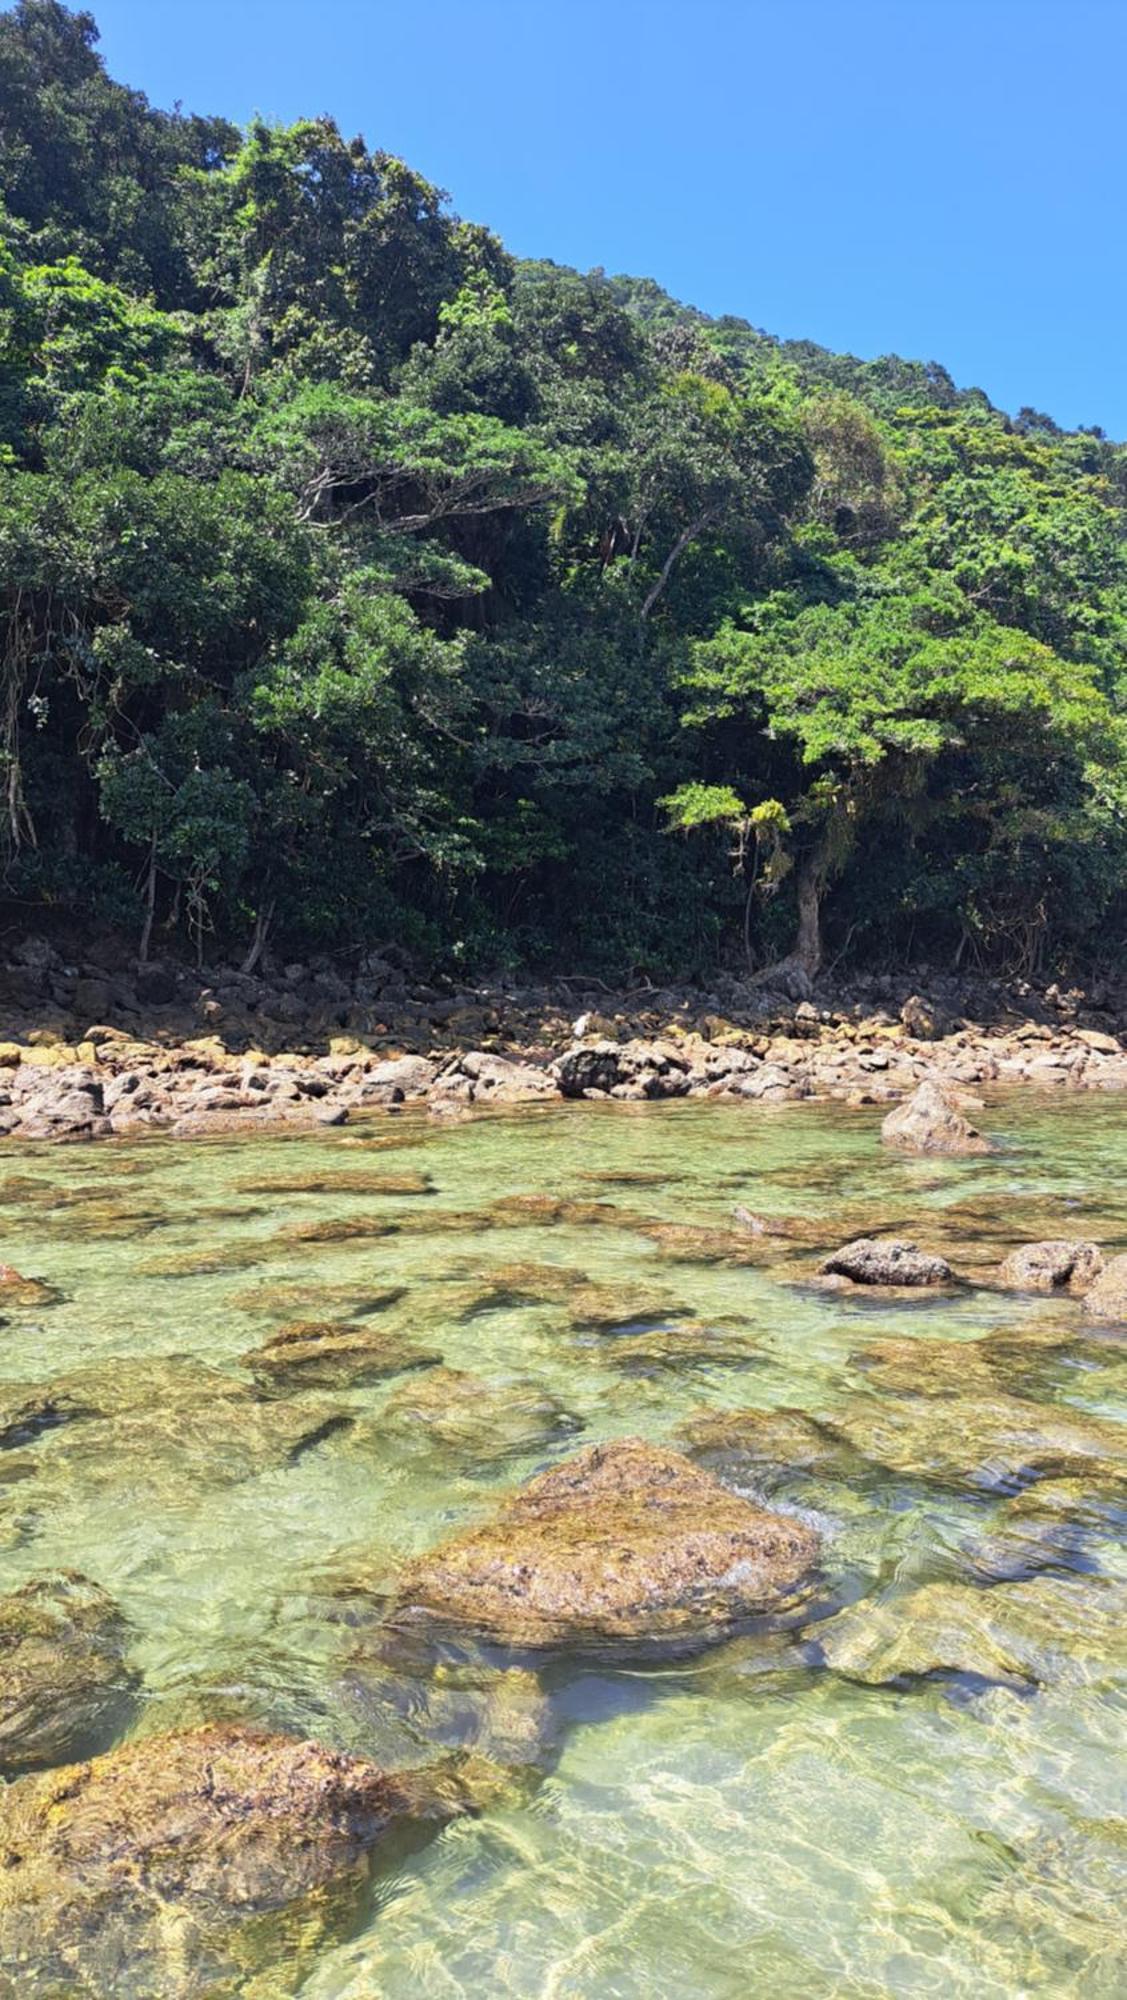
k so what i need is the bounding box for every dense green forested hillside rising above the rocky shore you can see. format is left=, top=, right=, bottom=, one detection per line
left=0, top=0, right=1127, bottom=980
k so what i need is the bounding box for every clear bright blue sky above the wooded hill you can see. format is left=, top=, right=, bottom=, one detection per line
left=88, top=0, right=1127, bottom=436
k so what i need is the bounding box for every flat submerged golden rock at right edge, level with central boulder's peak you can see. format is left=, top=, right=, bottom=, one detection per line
left=823, top=1388, right=1127, bottom=1492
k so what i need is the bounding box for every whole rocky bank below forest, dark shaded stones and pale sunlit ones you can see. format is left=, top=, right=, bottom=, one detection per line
left=0, top=938, right=1127, bottom=1140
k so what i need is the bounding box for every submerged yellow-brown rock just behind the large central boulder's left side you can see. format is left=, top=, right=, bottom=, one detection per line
left=375, top=1368, right=583, bottom=1462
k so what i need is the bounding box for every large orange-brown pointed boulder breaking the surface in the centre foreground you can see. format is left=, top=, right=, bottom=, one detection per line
left=391, top=1438, right=817, bottom=1650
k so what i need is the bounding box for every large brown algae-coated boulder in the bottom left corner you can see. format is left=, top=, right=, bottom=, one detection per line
left=0, top=1724, right=423, bottom=2000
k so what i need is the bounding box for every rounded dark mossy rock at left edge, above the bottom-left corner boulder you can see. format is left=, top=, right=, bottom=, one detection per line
left=0, top=1570, right=136, bottom=1772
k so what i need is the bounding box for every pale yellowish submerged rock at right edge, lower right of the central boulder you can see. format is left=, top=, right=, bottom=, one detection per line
left=809, top=1576, right=1127, bottom=1686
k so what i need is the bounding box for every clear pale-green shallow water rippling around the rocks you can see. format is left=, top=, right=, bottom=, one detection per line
left=0, top=1096, right=1127, bottom=2000
